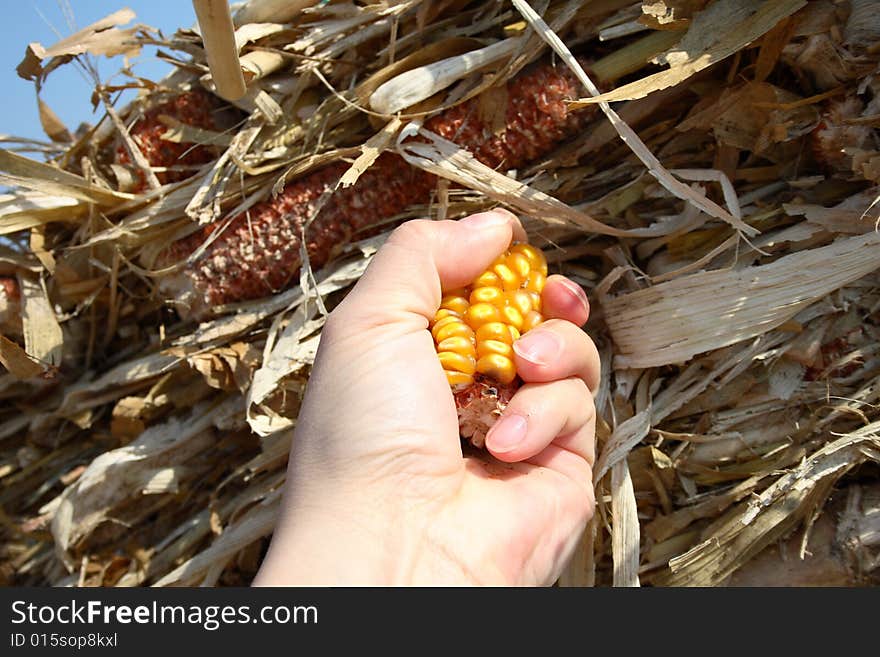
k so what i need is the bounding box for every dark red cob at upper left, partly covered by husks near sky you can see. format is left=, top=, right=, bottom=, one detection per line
left=115, top=89, right=217, bottom=193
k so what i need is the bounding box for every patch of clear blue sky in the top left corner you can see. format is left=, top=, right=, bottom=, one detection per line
left=0, top=0, right=220, bottom=145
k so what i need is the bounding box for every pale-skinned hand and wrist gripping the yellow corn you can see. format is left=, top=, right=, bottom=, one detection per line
left=254, top=210, right=600, bottom=586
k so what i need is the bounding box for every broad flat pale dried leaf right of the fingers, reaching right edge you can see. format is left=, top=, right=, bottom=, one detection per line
left=602, top=233, right=880, bottom=368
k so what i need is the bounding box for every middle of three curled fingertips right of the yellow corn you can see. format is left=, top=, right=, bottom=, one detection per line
left=513, top=319, right=600, bottom=393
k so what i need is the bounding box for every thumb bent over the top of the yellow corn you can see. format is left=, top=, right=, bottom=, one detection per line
left=334, top=209, right=526, bottom=326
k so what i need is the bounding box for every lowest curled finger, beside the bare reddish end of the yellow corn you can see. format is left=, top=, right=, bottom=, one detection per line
left=486, top=377, right=596, bottom=468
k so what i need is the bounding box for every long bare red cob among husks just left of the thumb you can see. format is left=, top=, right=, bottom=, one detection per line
left=161, top=154, right=434, bottom=316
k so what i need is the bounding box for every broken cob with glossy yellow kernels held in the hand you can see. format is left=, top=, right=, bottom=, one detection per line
left=430, top=244, right=547, bottom=447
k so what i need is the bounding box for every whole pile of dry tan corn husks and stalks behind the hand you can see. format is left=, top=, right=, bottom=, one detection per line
left=0, top=0, right=880, bottom=586
